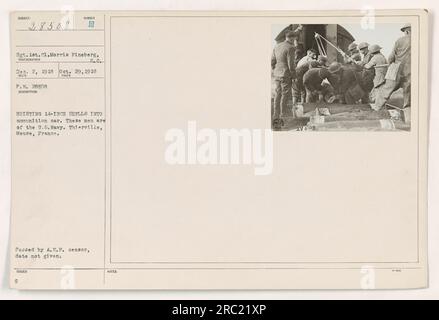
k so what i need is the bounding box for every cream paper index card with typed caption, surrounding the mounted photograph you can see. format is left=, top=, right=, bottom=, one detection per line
left=10, top=10, right=428, bottom=289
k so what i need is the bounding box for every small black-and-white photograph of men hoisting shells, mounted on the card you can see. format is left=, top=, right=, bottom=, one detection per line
left=271, top=23, right=411, bottom=131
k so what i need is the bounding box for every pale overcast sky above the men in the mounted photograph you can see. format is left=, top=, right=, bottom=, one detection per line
left=272, top=23, right=410, bottom=58
